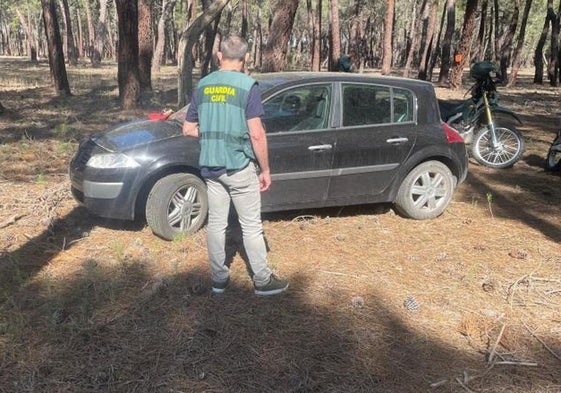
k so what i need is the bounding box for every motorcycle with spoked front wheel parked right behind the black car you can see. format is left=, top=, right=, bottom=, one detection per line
left=439, top=61, right=526, bottom=168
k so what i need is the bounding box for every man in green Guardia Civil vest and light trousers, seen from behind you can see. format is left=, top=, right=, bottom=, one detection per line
left=183, top=36, right=288, bottom=295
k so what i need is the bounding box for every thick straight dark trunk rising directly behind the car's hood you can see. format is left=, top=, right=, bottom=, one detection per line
left=115, top=0, right=140, bottom=109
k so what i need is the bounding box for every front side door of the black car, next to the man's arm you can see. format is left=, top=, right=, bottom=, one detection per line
left=262, top=83, right=335, bottom=211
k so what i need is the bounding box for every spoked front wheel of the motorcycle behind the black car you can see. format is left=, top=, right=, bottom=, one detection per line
left=471, top=124, right=526, bottom=169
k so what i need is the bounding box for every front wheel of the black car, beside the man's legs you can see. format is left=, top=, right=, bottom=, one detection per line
left=146, top=173, right=208, bottom=240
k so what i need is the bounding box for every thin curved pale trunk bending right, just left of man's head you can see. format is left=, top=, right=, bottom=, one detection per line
left=177, top=0, right=230, bottom=107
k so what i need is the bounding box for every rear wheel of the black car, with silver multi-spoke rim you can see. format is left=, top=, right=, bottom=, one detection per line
left=395, top=161, right=456, bottom=220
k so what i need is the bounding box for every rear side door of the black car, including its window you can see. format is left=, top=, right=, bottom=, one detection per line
left=329, top=83, right=416, bottom=201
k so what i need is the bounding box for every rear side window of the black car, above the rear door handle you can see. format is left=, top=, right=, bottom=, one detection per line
left=343, top=84, right=414, bottom=127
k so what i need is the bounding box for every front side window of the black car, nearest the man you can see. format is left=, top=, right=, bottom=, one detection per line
left=263, top=84, right=331, bottom=133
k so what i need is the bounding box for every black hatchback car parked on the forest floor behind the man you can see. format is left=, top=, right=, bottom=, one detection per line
left=70, top=72, right=468, bottom=239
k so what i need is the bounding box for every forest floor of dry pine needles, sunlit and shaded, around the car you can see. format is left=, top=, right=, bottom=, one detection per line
left=0, top=58, right=561, bottom=393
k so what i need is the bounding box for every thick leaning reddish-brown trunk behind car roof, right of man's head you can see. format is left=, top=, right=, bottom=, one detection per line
left=262, top=0, right=298, bottom=72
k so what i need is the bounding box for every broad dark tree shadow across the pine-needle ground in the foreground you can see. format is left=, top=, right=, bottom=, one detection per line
left=0, top=209, right=561, bottom=393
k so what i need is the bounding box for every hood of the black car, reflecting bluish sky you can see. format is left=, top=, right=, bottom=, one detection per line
left=92, top=120, right=182, bottom=152
